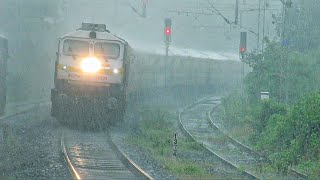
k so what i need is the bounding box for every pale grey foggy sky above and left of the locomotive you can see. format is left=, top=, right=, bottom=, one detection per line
left=0, top=0, right=281, bottom=102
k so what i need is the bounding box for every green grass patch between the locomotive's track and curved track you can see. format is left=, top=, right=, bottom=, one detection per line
left=128, top=110, right=214, bottom=179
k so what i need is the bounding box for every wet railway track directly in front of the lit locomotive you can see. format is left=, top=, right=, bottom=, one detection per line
left=61, top=130, right=152, bottom=179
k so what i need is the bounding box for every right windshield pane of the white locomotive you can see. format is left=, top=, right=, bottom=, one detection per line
left=94, top=42, right=120, bottom=59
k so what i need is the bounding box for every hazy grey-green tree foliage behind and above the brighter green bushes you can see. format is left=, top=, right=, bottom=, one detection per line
left=244, top=42, right=320, bottom=103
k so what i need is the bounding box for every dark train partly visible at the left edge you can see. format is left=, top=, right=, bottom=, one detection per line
left=0, top=36, right=9, bottom=115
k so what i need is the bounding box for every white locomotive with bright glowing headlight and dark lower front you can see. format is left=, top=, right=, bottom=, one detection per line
left=51, top=23, right=134, bottom=129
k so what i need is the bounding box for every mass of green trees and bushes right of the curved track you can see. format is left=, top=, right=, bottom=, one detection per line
left=218, top=1, right=320, bottom=176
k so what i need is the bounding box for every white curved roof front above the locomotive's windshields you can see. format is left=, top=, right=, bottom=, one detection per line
left=62, top=29, right=127, bottom=44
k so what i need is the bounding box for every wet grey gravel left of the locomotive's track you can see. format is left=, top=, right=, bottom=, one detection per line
left=0, top=107, right=72, bottom=179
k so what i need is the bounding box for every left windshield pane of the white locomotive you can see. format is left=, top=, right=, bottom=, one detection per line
left=63, top=39, right=89, bottom=56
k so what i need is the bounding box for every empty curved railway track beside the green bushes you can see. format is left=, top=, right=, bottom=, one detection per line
left=179, top=98, right=306, bottom=179
